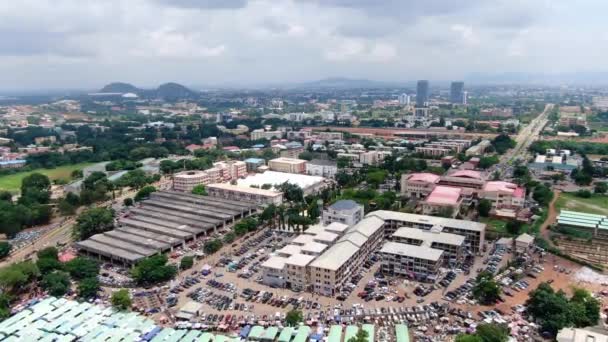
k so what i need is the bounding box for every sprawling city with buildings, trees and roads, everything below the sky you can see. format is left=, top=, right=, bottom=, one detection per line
left=0, top=80, right=608, bottom=342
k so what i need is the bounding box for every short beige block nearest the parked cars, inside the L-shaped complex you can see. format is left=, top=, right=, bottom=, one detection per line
left=380, top=241, right=444, bottom=282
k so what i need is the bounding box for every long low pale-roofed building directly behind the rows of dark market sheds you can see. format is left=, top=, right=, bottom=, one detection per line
left=206, top=183, right=283, bottom=205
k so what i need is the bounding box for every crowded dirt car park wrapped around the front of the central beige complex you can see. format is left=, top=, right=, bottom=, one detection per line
left=110, top=219, right=608, bottom=341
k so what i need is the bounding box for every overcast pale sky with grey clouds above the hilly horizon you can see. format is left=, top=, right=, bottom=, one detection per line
left=0, top=0, right=608, bottom=90
